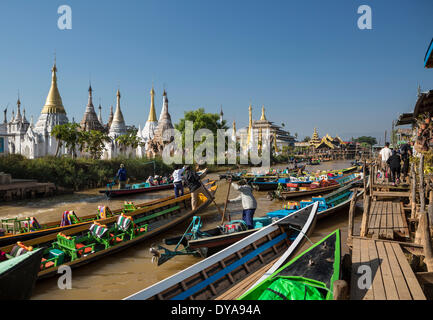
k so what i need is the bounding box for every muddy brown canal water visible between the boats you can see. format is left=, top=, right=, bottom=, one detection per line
left=0, top=161, right=362, bottom=300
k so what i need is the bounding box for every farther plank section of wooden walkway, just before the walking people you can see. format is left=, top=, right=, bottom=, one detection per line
left=367, top=201, right=409, bottom=240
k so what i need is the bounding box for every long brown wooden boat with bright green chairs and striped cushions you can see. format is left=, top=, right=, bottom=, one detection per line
left=0, top=183, right=217, bottom=278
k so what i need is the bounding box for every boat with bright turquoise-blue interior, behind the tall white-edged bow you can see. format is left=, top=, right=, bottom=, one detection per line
left=266, top=182, right=364, bottom=219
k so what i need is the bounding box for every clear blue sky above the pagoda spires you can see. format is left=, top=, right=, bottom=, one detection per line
left=0, top=0, right=433, bottom=143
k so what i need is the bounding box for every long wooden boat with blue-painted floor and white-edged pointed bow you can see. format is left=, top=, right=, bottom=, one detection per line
left=126, top=204, right=317, bottom=300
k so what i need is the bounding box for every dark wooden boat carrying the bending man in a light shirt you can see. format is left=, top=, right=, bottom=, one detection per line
left=155, top=216, right=278, bottom=265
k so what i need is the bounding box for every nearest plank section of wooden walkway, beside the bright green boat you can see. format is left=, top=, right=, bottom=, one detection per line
left=350, top=238, right=426, bottom=300
